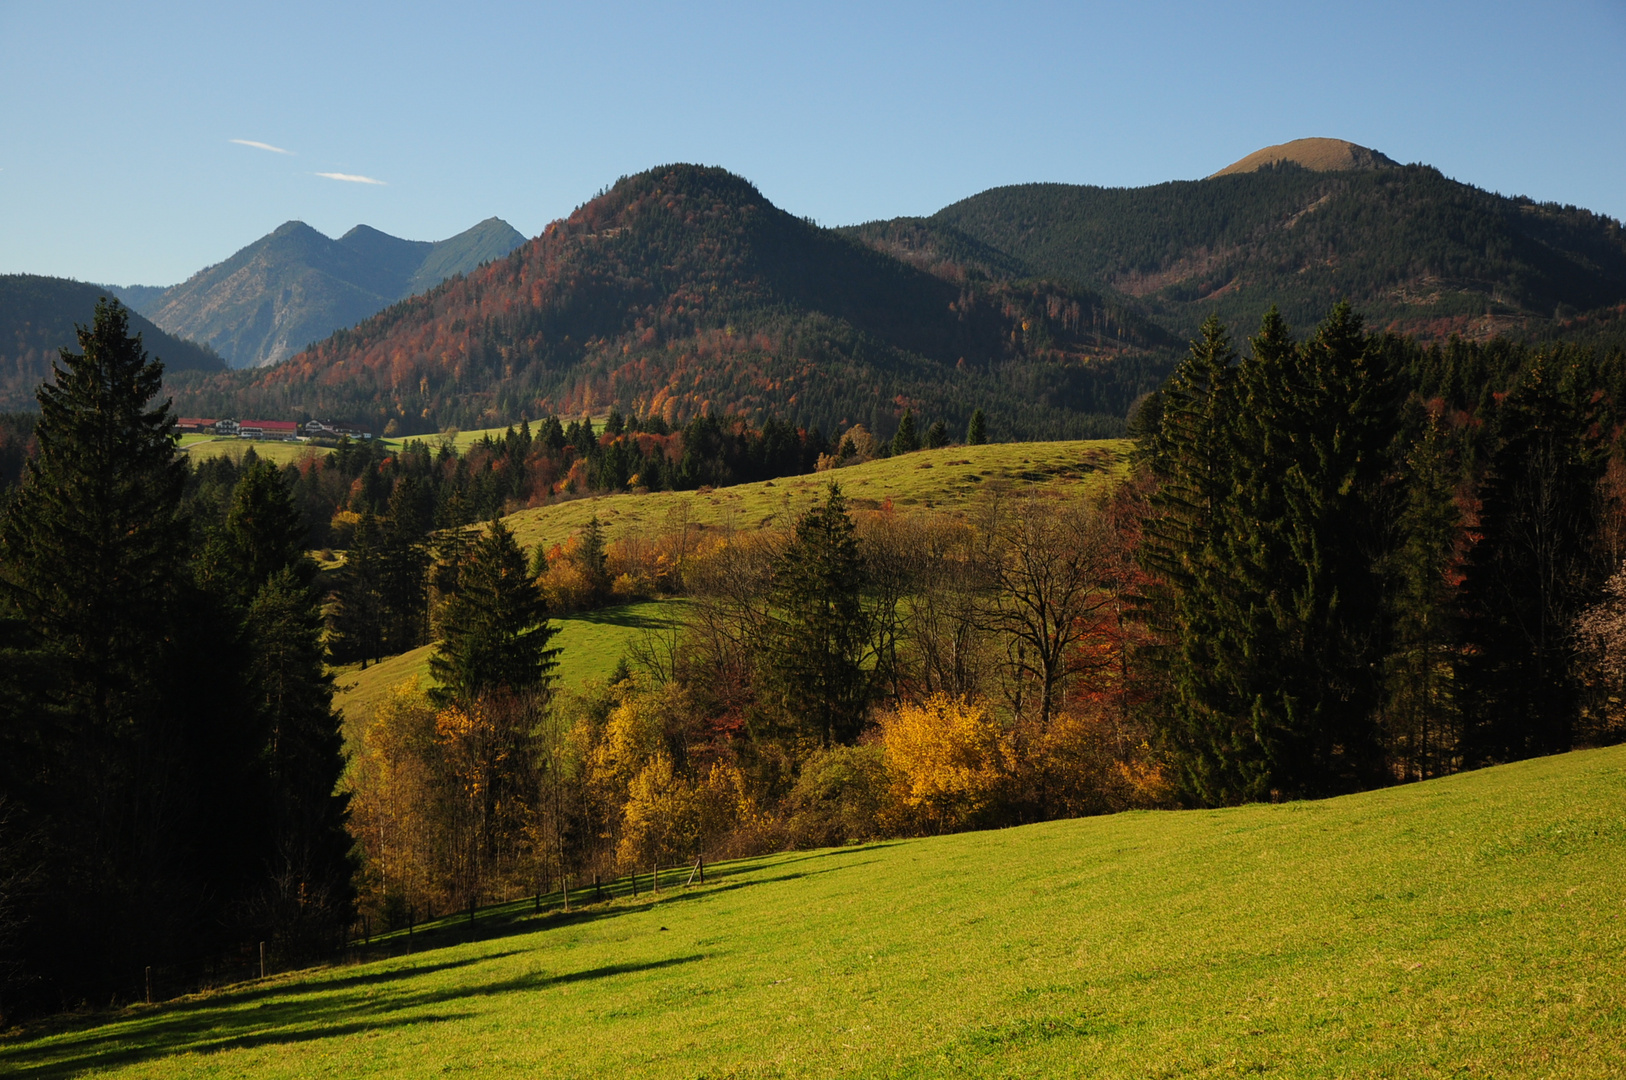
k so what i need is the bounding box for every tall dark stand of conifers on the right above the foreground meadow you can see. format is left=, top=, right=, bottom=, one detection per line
left=1141, top=304, right=1626, bottom=803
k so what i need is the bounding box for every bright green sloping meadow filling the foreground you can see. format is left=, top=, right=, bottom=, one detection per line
left=0, top=748, right=1626, bottom=1078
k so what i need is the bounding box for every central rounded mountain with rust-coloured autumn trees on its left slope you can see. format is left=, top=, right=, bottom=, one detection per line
left=176, top=164, right=1176, bottom=438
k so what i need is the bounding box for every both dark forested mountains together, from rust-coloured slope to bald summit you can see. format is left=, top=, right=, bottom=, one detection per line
left=176, top=140, right=1626, bottom=438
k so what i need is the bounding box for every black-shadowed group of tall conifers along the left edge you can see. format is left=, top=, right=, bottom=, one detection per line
left=0, top=304, right=354, bottom=1017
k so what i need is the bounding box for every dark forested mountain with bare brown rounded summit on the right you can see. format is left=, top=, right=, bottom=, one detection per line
left=849, top=140, right=1626, bottom=338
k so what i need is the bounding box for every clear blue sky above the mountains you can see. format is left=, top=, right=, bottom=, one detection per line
left=0, top=0, right=1626, bottom=285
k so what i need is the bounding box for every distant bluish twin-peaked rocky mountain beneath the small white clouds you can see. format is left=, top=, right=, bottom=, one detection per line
left=115, top=218, right=525, bottom=368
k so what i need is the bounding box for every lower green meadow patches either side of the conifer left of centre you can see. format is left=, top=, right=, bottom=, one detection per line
left=333, top=600, right=681, bottom=729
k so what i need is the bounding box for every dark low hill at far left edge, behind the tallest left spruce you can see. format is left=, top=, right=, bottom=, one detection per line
left=0, top=273, right=226, bottom=412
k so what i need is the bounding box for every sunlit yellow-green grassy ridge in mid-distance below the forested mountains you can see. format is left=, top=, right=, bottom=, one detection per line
left=506, top=439, right=1130, bottom=548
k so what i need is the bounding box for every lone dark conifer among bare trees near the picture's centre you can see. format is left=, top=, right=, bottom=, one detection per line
left=764, top=485, right=870, bottom=745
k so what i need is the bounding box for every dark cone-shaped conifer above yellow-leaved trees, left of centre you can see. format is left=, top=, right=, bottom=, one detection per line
left=429, top=520, right=558, bottom=704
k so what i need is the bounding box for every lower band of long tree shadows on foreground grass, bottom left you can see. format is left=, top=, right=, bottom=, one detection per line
left=0, top=953, right=706, bottom=1080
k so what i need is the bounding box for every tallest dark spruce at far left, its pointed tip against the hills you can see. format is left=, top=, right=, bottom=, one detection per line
left=0, top=301, right=235, bottom=997
